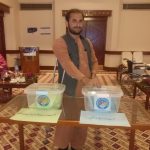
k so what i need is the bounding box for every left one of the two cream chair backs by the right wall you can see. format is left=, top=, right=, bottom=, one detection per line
left=121, top=52, right=132, bottom=66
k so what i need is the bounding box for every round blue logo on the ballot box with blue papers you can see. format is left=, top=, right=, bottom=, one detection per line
left=96, top=98, right=109, bottom=109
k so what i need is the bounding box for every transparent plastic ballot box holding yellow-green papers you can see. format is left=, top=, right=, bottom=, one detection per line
left=24, top=83, right=65, bottom=109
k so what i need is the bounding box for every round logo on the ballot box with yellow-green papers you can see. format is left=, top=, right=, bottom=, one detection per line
left=37, top=95, right=50, bottom=106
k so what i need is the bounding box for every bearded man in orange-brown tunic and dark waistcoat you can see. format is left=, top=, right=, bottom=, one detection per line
left=53, top=9, right=100, bottom=150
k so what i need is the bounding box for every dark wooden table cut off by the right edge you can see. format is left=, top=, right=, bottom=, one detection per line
left=133, top=82, right=150, bottom=109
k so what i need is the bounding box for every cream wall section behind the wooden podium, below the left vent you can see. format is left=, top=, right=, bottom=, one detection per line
left=19, top=0, right=56, bottom=66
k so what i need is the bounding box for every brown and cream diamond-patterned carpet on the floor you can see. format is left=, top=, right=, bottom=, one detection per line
left=0, top=72, right=150, bottom=150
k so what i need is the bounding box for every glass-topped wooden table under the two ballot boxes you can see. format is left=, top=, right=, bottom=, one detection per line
left=0, top=94, right=150, bottom=150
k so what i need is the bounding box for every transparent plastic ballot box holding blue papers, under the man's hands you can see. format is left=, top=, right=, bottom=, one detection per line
left=82, top=86, right=123, bottom=112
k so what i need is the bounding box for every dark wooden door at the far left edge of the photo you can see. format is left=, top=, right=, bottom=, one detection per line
left=0, top=12, right=6, bottom=58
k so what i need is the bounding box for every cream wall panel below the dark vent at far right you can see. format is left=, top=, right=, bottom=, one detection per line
left=118, top=10, right=150, bottom=51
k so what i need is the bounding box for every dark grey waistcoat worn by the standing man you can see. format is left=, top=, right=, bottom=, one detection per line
left=58, top=34, right=92, bottom=96
